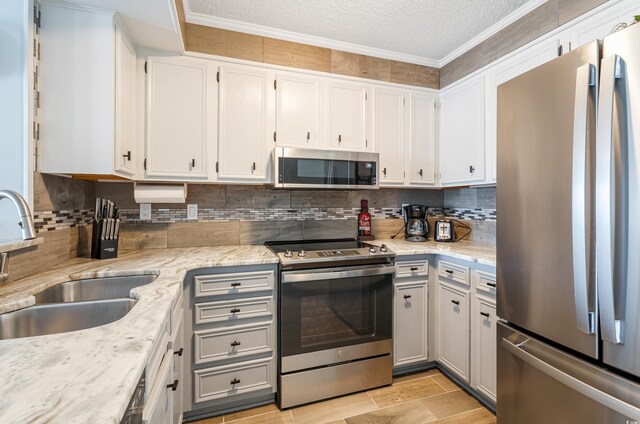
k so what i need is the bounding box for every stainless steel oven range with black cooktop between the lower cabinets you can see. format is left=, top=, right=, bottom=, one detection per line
left=266, top=239, right=395, bottom=408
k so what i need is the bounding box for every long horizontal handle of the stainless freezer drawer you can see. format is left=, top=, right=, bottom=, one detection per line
left=501, top=338, right=640, bottom=420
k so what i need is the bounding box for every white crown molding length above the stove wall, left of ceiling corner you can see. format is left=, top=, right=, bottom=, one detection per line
left=185, top=5, right=439, bottom=67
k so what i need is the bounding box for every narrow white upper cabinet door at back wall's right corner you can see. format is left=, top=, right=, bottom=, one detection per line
left=407, top=93, right=436, bottom=185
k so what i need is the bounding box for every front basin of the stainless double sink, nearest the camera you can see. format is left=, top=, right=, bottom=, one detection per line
left=0, top=298, right=137, bottom=340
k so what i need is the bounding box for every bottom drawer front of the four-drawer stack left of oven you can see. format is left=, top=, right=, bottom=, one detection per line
left=193, top=358, right=273, bottom=403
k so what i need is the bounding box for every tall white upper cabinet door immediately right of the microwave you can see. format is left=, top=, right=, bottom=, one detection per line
left=374, top=89, right=404, bottom=186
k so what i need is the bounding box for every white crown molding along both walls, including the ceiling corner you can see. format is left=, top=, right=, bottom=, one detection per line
left=184, top=0, right=548, bottom=68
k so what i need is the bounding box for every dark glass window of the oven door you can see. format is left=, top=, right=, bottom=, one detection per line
left=280, top=274, right=392, bottom=356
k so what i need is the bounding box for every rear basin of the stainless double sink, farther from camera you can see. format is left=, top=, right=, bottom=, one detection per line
left=35, top=274, right=157, bottom=305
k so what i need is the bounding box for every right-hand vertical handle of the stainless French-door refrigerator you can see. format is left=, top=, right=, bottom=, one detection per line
left=596, top=55, right=624, bottom=344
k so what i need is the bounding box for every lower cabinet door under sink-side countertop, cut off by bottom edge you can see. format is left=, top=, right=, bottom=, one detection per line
left=142, top=350, right=174, bottom=424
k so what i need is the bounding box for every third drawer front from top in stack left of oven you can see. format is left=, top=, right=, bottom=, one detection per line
left=194, top=323, right=273, bottom=364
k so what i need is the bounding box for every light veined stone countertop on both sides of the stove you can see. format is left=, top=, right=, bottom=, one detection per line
left=0, top=239, right=495, bottom=424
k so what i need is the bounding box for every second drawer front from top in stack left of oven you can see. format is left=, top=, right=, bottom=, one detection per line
left=194, top=296, right=273, bottom=325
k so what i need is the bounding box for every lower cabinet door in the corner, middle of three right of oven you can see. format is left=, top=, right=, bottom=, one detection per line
left=438, top=283, right=469, bottom=382
